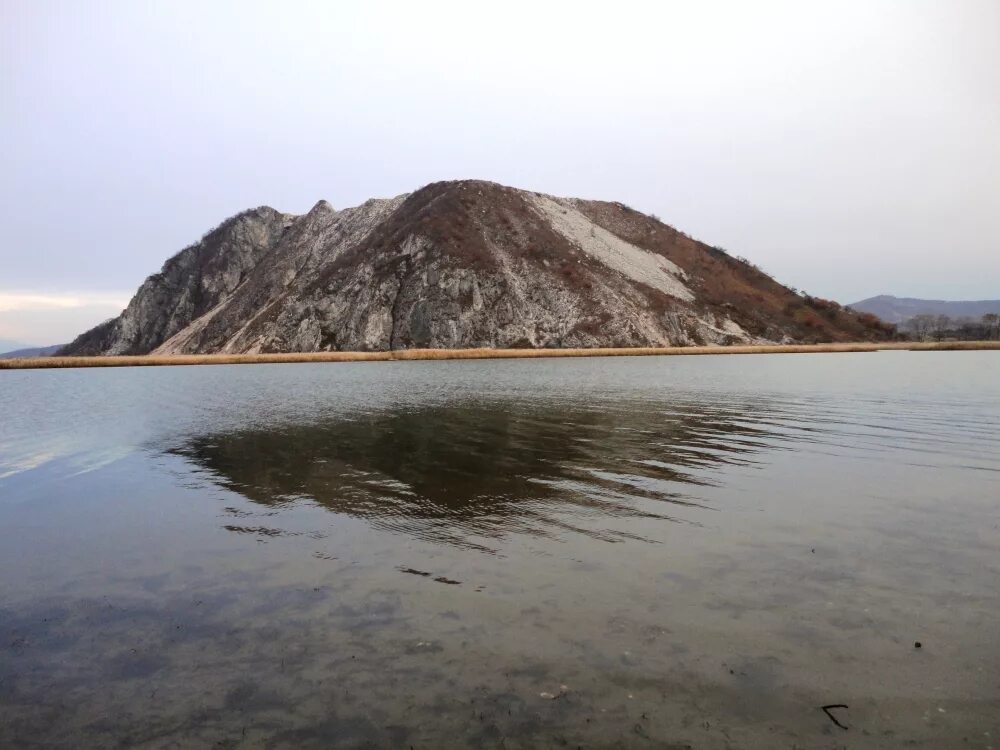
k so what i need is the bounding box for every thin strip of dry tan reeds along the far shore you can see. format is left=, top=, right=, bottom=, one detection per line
left=0, top=341, right=1000, bottom=370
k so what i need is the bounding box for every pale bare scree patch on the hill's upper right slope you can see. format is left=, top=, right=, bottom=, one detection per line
left=529, top=195, right=694, bottom=302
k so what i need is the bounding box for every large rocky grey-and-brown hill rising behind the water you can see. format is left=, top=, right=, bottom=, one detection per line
left=62, top=180, right=890, bottom=355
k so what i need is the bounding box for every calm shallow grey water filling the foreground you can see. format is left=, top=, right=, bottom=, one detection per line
left=0, top=352, right=1000, bottom=749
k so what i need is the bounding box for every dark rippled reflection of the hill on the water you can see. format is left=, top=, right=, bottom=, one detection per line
left=172, top=401, right=796, bottom=546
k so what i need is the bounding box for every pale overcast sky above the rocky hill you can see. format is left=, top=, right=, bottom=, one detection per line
left=0, top=0, right=1000, bottom=344
